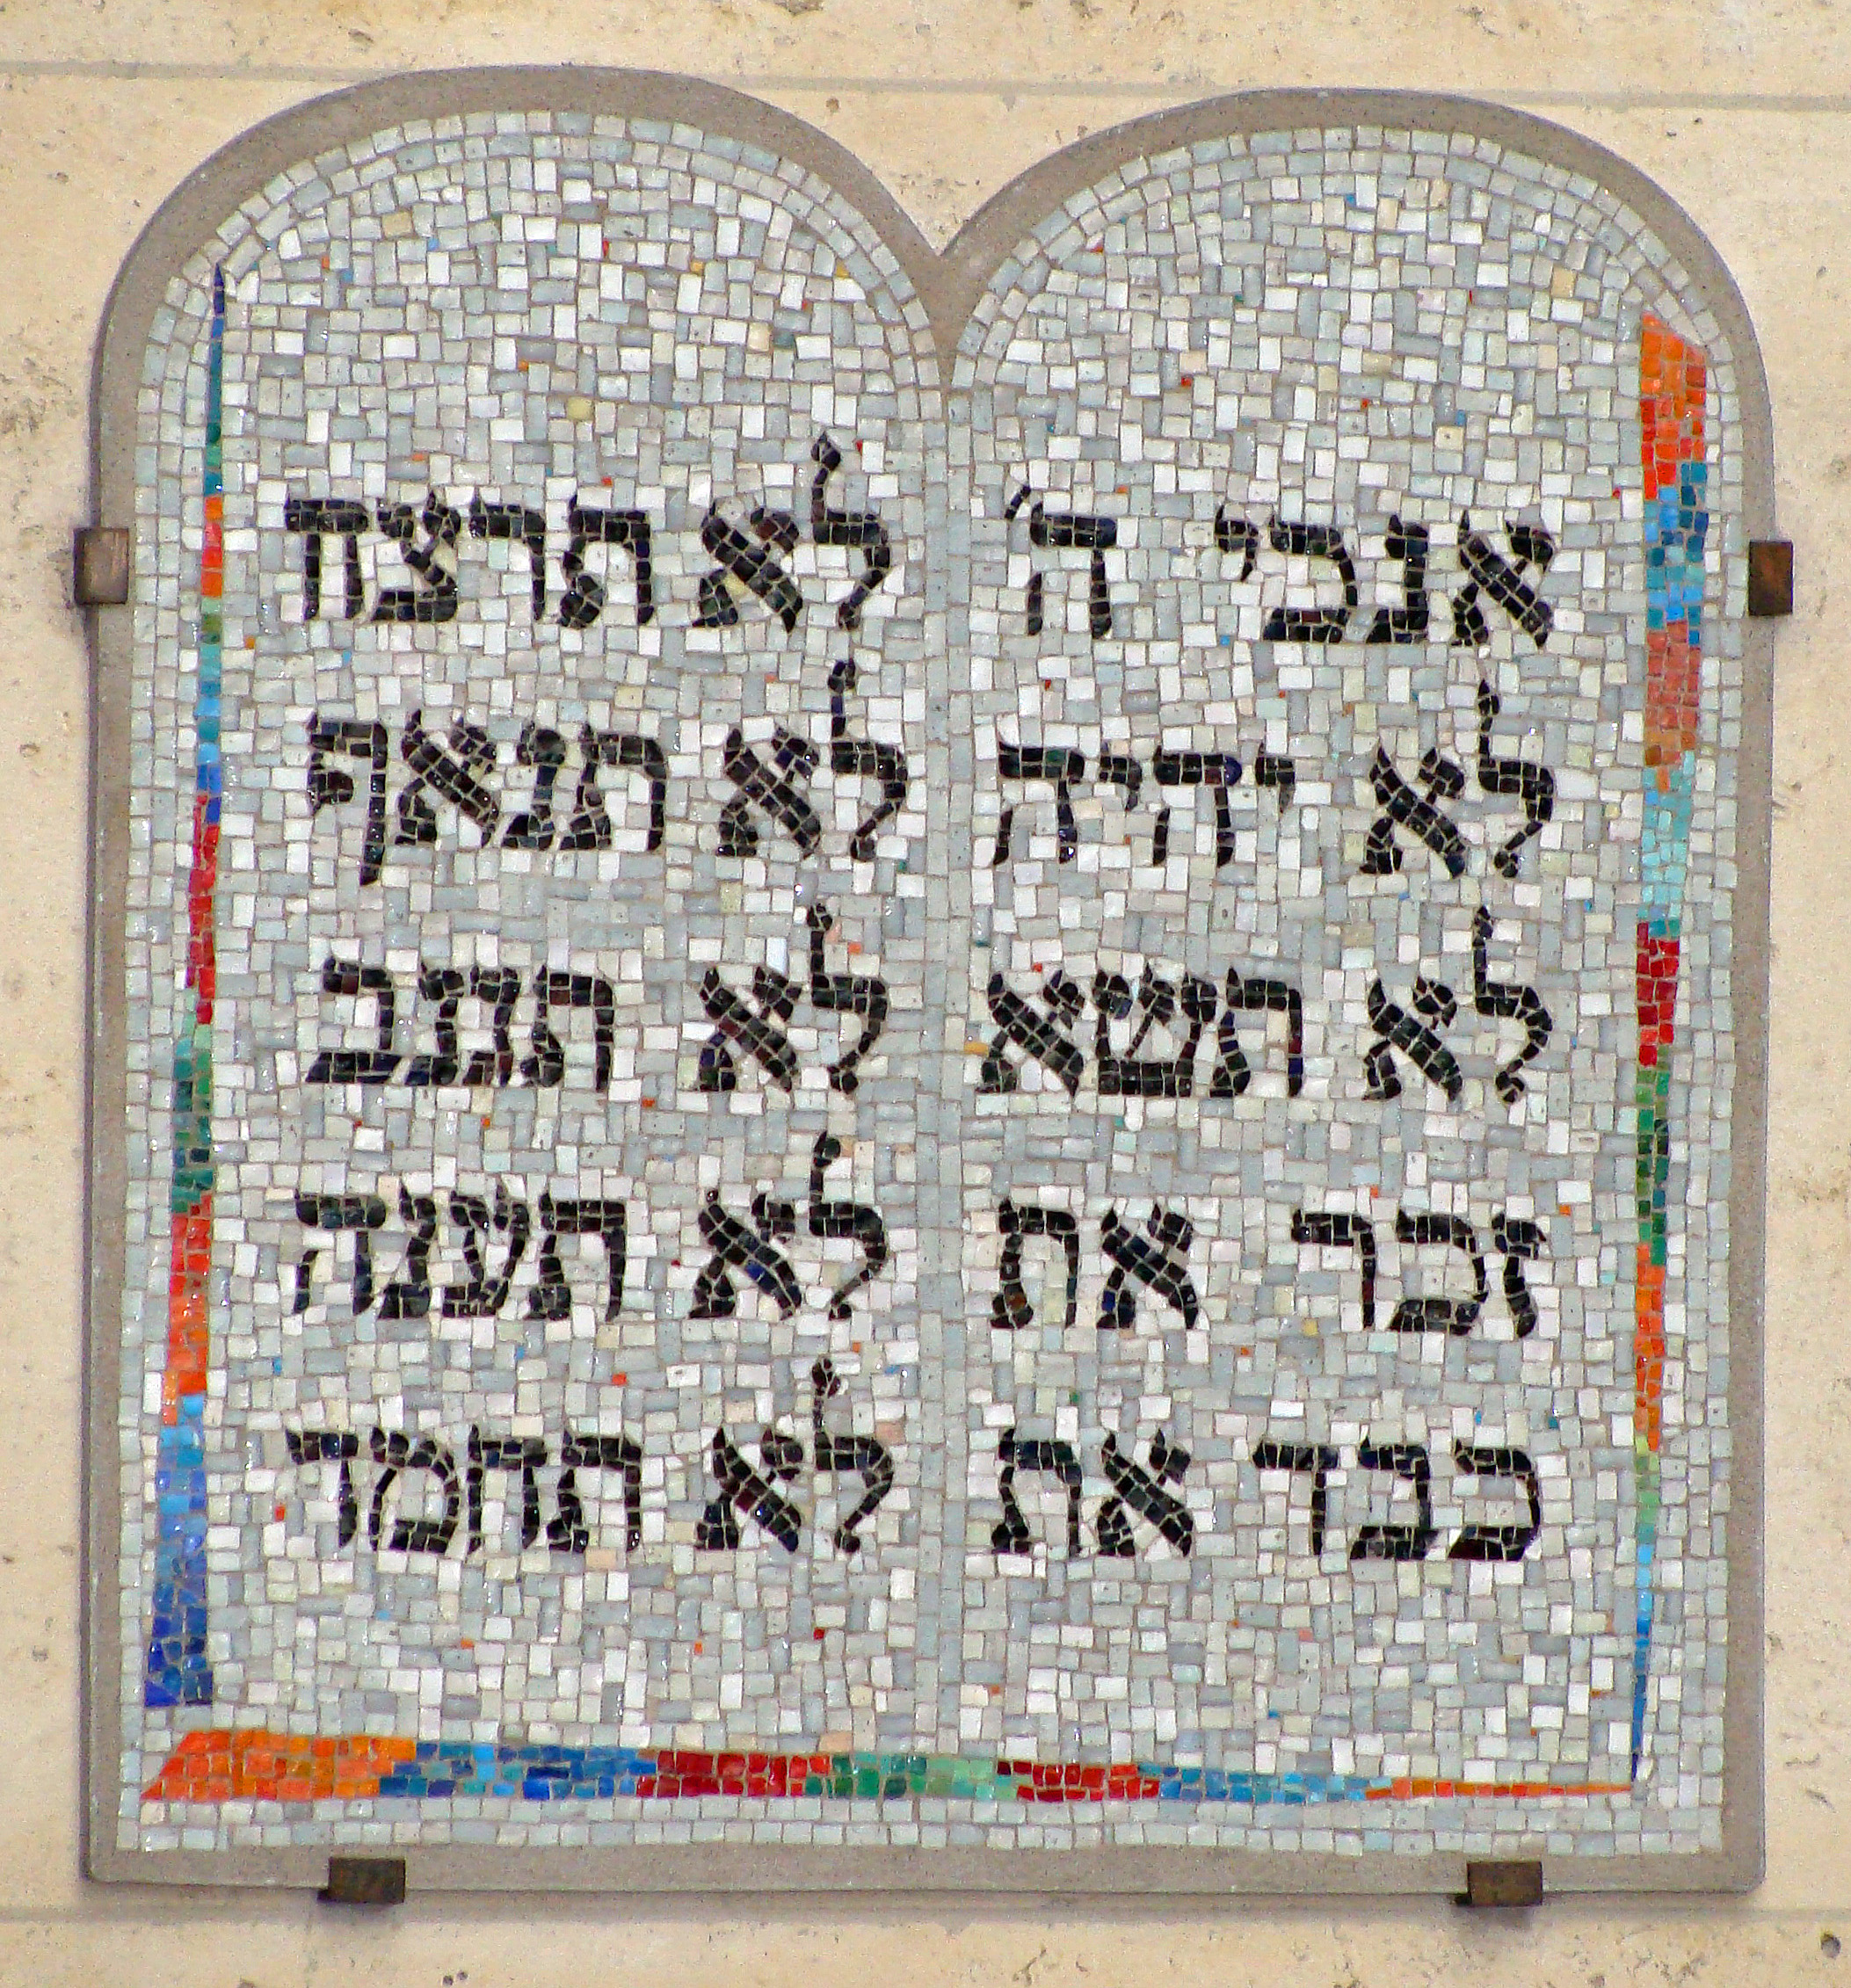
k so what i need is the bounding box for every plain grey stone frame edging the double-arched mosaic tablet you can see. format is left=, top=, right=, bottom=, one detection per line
left=83, top=68, right=1774, bottom=1914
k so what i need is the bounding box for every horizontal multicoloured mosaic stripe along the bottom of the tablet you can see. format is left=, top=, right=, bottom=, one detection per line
left=152, top=1728, right=1632, bottom=1807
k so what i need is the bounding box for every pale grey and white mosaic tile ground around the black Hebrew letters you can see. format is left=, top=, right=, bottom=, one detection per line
left=121, top=117, right=1739, bottom=1853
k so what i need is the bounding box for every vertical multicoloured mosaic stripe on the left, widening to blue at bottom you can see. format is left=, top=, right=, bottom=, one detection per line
left=143, top=268, right=225, bottom=1706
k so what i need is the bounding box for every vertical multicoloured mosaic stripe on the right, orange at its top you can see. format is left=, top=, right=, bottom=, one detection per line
left=1632, top=316, right=1709, bottom=1781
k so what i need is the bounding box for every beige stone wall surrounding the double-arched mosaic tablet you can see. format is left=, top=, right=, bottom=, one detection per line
left=0, top=0, right=1851, bottom=1988
